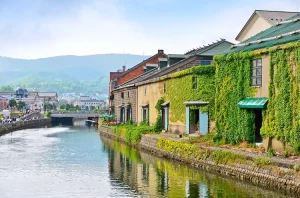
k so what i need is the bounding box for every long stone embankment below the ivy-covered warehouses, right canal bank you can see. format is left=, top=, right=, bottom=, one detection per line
left=99, top=126, right=300, bottom=195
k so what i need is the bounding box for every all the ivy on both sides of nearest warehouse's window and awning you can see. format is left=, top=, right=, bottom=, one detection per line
left=214, top=42, right=300, bottom=149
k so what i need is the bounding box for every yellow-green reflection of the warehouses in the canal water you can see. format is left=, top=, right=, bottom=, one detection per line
left=101, top=136, right=296, bottom=198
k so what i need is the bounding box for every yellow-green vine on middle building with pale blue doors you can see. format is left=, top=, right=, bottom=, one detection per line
left=163, top=66, right=215, bottom=123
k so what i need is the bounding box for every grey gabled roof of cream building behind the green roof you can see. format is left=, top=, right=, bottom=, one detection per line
left=235, top=10, right=300, bottom=40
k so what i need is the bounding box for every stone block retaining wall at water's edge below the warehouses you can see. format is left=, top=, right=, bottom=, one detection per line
left=99, top=127, right=300, bottom=195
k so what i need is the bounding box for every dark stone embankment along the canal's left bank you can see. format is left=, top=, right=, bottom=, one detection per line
left=0, top=118, right=51, bottom=136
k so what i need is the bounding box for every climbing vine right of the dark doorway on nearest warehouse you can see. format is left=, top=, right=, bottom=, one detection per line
left=261, top=45, right=300, bottom=152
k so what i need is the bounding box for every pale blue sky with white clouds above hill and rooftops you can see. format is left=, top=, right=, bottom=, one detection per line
left=0, top=0, right=300, bottom=59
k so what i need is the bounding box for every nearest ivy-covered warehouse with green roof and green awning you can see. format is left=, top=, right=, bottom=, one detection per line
left=215, top=12, right=300, bottom=151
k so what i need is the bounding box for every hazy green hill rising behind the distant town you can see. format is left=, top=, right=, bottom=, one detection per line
left=0, top=54, right=148, bottom=94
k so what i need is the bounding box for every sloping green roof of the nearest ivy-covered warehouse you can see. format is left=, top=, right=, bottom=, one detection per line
left=225, top=14, right=300, bottom=54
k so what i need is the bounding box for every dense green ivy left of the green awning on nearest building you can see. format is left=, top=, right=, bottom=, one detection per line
left=214, top=52, right=255, bottom=144
